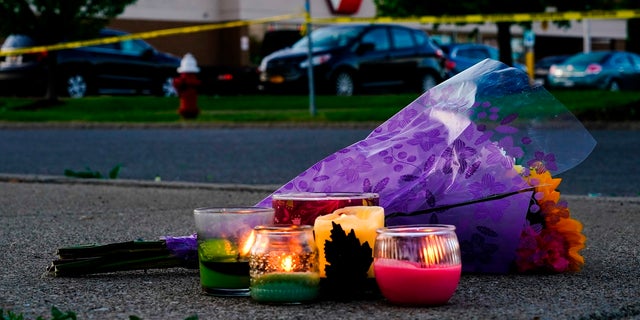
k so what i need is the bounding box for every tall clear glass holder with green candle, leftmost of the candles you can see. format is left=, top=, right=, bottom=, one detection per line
left=193, top=207, right=273, bottom=297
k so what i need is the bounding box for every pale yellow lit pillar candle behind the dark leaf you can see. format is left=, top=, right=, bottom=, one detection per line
left=313, top=206, right=384, bottom=278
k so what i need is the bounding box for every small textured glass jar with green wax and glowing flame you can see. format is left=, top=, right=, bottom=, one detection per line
left=249, top=225, right=320, bottom=304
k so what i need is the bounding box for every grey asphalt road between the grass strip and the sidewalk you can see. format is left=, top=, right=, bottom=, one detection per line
left=0, top=128, right=640, bottom=196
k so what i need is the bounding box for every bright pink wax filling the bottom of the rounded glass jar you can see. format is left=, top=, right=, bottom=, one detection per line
left=373, top=259, right=462, bottom=305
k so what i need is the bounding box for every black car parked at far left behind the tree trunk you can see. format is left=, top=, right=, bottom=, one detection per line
left=0, top=29, right=181, bottom=98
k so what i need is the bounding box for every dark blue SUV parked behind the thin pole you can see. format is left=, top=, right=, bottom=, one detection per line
left=259, top=24, right=445, bottom=96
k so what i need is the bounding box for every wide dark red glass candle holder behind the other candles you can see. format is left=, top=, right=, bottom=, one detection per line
left=271, top=192, right=380, bottom=225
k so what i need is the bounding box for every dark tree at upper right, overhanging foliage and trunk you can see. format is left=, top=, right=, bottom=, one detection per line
left=374, top=0, right=637, bottom=65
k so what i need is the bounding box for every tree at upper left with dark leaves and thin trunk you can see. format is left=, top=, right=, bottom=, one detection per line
left=0, top=0, right=137, bottom=102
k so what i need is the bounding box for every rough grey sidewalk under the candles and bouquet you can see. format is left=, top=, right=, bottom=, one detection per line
left=0, top=175, right=640, bottom=320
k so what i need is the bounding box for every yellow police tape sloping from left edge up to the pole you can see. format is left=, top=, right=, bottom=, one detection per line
left=0, top=14, right=304, bottom=57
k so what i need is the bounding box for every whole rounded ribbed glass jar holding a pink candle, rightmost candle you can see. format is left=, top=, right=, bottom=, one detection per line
left=373, top=224, right=462, bottom=306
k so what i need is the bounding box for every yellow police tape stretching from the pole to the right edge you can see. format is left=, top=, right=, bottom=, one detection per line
left=311, top=10, right=640, bottom=24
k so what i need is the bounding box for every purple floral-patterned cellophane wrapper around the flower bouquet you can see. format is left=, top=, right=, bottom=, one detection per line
left=257, top=59, right=595, bottom=273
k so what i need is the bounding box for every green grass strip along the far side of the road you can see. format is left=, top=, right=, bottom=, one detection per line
left=0, top=90, right=640, bottom=127
